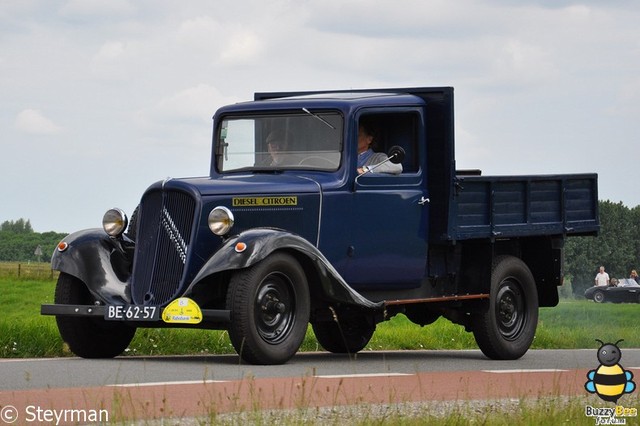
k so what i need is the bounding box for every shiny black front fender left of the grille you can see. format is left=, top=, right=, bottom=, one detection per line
left=51, top=228, right=132, bottom=304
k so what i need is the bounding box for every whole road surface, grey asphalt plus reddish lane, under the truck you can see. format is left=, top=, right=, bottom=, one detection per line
left=0, top=345, right=640, bottom=425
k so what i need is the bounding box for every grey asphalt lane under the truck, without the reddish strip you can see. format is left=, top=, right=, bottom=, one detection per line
left=0, top=348, right=640, bottom=391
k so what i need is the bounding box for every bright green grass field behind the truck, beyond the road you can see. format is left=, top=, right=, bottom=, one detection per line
left=0, top=272, right=640, bottom=358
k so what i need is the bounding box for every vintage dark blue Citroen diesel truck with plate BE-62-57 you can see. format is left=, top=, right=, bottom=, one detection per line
left=41, top=87, right=599, bottom=364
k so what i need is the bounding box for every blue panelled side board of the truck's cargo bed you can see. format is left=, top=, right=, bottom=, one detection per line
left=448, top=174, right=599, bottom=240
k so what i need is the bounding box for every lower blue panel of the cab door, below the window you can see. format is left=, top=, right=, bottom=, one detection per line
left=344, top=176, right=428, bottom=290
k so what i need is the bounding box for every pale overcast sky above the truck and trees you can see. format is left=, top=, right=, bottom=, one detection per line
left=0, top=0, right=640, bottom=232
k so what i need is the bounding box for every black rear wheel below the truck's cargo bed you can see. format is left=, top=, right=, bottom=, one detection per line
left=472, top=256, right=538, bottom=359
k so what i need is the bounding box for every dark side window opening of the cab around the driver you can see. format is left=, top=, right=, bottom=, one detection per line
left=358, top=112, right=419, bottom=173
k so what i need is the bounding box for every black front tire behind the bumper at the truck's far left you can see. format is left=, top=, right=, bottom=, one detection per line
left=54, top=272, right=136, bottom=358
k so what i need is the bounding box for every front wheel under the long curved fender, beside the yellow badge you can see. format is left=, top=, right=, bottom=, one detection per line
left=227, top=253, right=310, bottom=365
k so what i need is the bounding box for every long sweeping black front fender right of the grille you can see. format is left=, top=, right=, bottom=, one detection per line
left=185, top=228, right=383, bottom=309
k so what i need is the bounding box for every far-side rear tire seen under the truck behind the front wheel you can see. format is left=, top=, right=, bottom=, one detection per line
left=311, top=317, right=376, bottom=354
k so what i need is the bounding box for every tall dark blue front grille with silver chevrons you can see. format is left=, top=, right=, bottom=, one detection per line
left=131, top=191, right=196, bottom=305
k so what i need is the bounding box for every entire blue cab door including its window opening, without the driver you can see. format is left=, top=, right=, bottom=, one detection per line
left=344, top=108, right=429, bottom=290
